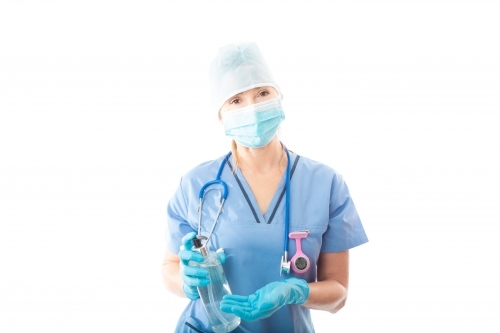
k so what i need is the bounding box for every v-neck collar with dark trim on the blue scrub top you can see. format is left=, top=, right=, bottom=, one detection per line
left=227, top=153, right=300, bottom=224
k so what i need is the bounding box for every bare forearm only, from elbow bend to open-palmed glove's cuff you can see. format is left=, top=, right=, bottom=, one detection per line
left=303, top=280, right=347, bottom=313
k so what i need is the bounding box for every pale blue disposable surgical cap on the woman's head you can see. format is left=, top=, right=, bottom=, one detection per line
left=210, top=43, right=282, bottom=111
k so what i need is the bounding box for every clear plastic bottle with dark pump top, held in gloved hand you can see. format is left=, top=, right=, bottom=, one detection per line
left=195, top=242, right=241, bottom=333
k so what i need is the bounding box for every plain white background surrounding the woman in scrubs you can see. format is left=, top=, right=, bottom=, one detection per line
left=0, top=0, right=500, bottom=332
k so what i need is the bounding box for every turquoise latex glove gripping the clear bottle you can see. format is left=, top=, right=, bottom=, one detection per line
left=177, top=232, right=226, bottom=301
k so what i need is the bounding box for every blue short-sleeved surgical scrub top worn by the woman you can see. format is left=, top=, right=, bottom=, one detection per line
left=165, top=153, right=368, bottom=333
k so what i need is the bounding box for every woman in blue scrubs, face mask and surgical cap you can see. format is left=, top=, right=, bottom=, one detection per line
left=162, top=43, right=368, bottom=332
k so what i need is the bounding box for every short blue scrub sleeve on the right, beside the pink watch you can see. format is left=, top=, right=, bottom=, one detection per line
left=321, top=175, right=368, bottom=252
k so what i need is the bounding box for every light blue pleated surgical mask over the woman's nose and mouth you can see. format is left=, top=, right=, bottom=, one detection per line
left=221, top=97, right=285, bottom=148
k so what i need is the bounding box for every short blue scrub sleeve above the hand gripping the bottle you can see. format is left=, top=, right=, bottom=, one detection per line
left=165, top=179, right=196, bottom=253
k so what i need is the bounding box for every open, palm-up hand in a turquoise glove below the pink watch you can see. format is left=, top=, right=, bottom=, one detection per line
left=220, top=278, right=309, bottom=321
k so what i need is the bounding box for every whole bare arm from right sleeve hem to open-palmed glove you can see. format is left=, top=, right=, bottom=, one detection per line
left=303, top=251, right=349, bottom=313
